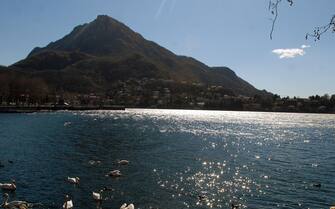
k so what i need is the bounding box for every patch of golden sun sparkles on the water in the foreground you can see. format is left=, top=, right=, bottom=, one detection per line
left=155, top=158, right=263, bottom=208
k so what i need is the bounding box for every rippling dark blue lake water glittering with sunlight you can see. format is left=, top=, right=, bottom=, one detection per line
left=0, top=109, right=335, bottom=209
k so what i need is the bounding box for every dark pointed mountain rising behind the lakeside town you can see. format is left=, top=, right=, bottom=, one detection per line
left=9, top=15, right=269, bottom=96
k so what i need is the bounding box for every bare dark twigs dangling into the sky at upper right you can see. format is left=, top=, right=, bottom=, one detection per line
left=269, top=0, right=335, bottom=41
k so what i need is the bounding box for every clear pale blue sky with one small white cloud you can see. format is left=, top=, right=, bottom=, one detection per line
left=0, top=0, right=335, bottom=97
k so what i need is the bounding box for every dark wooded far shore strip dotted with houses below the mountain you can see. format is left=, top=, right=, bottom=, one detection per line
left=0, top=78, right=335, bottom=113
